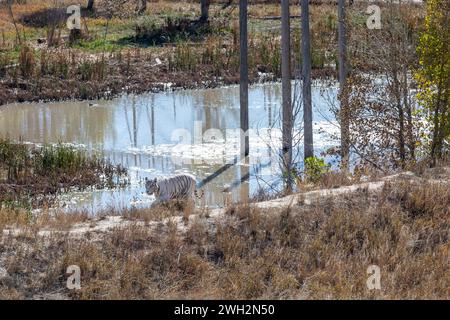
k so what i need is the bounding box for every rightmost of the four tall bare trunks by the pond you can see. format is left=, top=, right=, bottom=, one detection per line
left=338, top=0, right=350, bottom=171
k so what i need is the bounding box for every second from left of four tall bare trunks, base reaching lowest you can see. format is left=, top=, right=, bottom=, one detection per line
left=281, top=0, right=292, bottom=193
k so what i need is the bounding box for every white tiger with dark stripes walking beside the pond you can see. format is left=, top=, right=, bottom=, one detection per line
left=145, top=174, right=203, bottom=203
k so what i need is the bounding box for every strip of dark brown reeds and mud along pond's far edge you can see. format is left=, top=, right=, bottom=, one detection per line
left=0, top=57, right=335, bottom=106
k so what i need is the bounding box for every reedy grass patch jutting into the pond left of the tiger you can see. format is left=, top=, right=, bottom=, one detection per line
left=0, top=139, right=126, bottom=208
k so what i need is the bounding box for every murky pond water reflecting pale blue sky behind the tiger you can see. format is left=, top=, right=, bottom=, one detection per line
left=0, top=84, right=336, bottom=212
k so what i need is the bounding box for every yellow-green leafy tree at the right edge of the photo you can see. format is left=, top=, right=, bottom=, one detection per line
left=416, top=0, right=450, bottom=165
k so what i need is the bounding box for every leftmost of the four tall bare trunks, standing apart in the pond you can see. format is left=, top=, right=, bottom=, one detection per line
left=239, top=0, right=249, bottom=157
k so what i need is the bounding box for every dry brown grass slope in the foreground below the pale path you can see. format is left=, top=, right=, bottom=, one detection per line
left=0, top=178, right=450, bottom=299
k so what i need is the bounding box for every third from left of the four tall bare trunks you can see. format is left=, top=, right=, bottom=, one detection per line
left=301, top=0, right=314, bottom=159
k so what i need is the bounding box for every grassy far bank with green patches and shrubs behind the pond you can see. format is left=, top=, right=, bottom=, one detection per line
left=0, top=1, right=424, bottom=104
